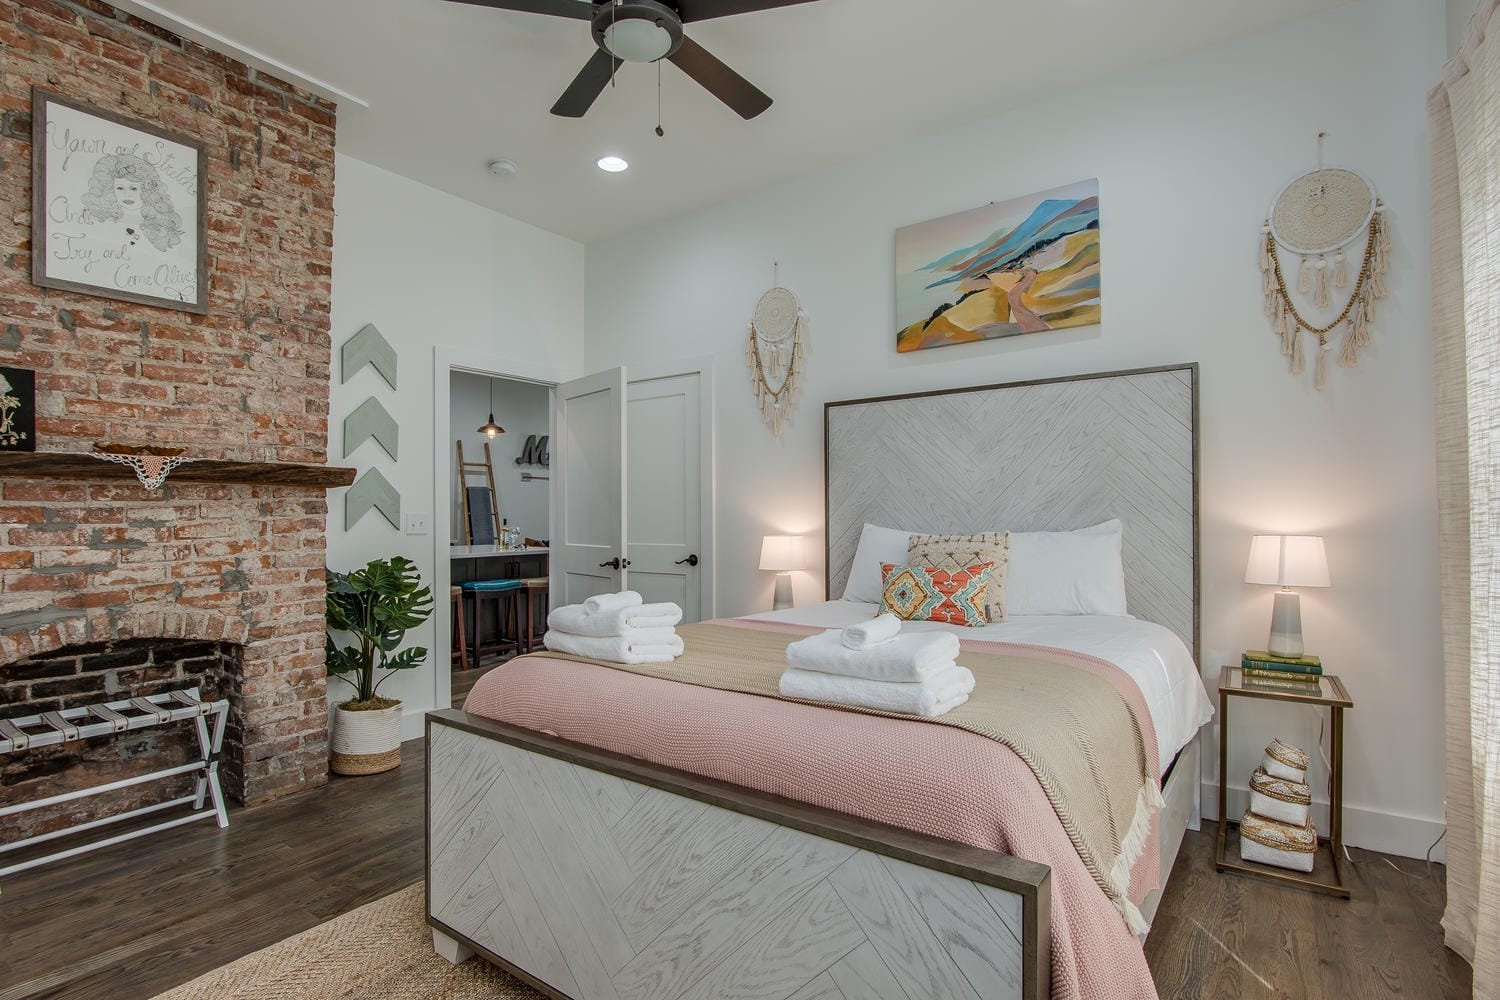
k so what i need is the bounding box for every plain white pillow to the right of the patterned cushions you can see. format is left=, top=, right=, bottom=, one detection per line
left=1008, top=520, right=1127, bottom=616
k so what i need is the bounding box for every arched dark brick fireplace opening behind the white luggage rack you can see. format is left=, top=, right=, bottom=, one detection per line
left=0, top=639, right=245, bottom=843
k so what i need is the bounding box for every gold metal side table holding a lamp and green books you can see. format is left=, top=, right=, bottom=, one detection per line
left=1214, top=667, right=1355, bottom=900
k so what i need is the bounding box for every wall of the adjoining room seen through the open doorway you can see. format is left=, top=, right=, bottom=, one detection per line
left=449, top=372, right=552, bottom=543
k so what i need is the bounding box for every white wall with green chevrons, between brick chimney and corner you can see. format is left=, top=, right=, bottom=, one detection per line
left=329, top=154, right=584, bottom=739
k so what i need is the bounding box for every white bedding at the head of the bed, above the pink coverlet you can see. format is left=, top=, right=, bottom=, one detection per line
left=747, top=601, right=1214, bottom=774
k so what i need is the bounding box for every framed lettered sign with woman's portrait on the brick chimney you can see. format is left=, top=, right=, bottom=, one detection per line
left=32, top=87, right=209, bottom=313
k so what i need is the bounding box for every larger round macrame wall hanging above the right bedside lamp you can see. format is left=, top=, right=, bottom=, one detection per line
left=1260, top=132, right=1391, bottom=390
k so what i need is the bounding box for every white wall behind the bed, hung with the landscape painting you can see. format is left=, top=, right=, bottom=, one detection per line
left=585, top=0, right=1446, bottom=853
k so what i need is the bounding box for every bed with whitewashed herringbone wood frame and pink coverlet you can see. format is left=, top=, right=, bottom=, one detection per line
left=428, top=366, right=1209, bottom=1000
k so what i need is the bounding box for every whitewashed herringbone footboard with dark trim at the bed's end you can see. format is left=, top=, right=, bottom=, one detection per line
left=426, top=711, right=1052, bottom=1000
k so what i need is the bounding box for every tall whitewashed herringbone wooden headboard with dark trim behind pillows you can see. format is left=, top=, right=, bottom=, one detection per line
left=824, top=364, right=1200, bottom=660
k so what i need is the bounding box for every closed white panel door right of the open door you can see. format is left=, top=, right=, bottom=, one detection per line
left=626, top=372, right=713, bottom=622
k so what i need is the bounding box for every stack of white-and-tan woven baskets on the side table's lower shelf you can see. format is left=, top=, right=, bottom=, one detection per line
left=1239, top=739, right=1317, bottom=871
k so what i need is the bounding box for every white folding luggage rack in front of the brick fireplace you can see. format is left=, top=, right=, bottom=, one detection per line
left=0, top=688, right=230, bottom=876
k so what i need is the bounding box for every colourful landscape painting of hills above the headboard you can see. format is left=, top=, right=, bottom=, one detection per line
left=896, top=180, right=1100, bottom=354
